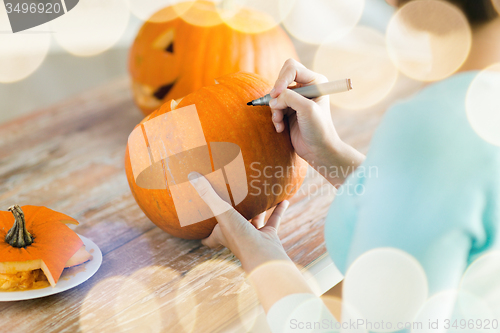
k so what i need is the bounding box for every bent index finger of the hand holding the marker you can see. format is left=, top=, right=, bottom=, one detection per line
left=270, top=59, right=328, bottom=98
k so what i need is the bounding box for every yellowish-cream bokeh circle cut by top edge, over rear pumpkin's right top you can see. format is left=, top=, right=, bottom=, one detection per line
left=219, top=0, right=296, bottom=33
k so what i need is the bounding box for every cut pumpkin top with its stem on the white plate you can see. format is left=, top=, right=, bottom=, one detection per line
left=0, top=205, right=92, bottom=290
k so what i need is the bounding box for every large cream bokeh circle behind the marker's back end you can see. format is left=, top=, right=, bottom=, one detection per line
left=313, top=26, right=398, bottom=110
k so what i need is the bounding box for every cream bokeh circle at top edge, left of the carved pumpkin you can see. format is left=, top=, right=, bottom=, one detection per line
left=50, top=0, right=130, bottom=56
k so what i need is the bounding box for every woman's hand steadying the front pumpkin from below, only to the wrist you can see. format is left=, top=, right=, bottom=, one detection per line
left=189, top=172, right=290, bottom=273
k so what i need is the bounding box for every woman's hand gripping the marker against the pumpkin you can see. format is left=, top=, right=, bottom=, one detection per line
left=269, top=59, right=364, bottom=186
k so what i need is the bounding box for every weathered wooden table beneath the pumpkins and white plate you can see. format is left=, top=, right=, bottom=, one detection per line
left=0, top=74, right=416, bottom=333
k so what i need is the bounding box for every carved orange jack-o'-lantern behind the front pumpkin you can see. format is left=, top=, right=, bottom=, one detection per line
left=129, top=1, right=298, bottom=115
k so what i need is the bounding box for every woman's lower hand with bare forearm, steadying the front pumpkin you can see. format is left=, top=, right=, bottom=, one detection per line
left=189, top=172, right=312, bottom=313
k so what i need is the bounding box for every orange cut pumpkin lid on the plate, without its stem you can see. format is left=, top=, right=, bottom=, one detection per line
left=0, top=206, right=92, bottom=287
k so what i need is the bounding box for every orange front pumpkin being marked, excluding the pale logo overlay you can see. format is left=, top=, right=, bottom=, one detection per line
left=125, top=73, right=307, bottom=239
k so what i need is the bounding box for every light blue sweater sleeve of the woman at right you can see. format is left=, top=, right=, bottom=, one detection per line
left=325, top=73, right=500, bottom=294
